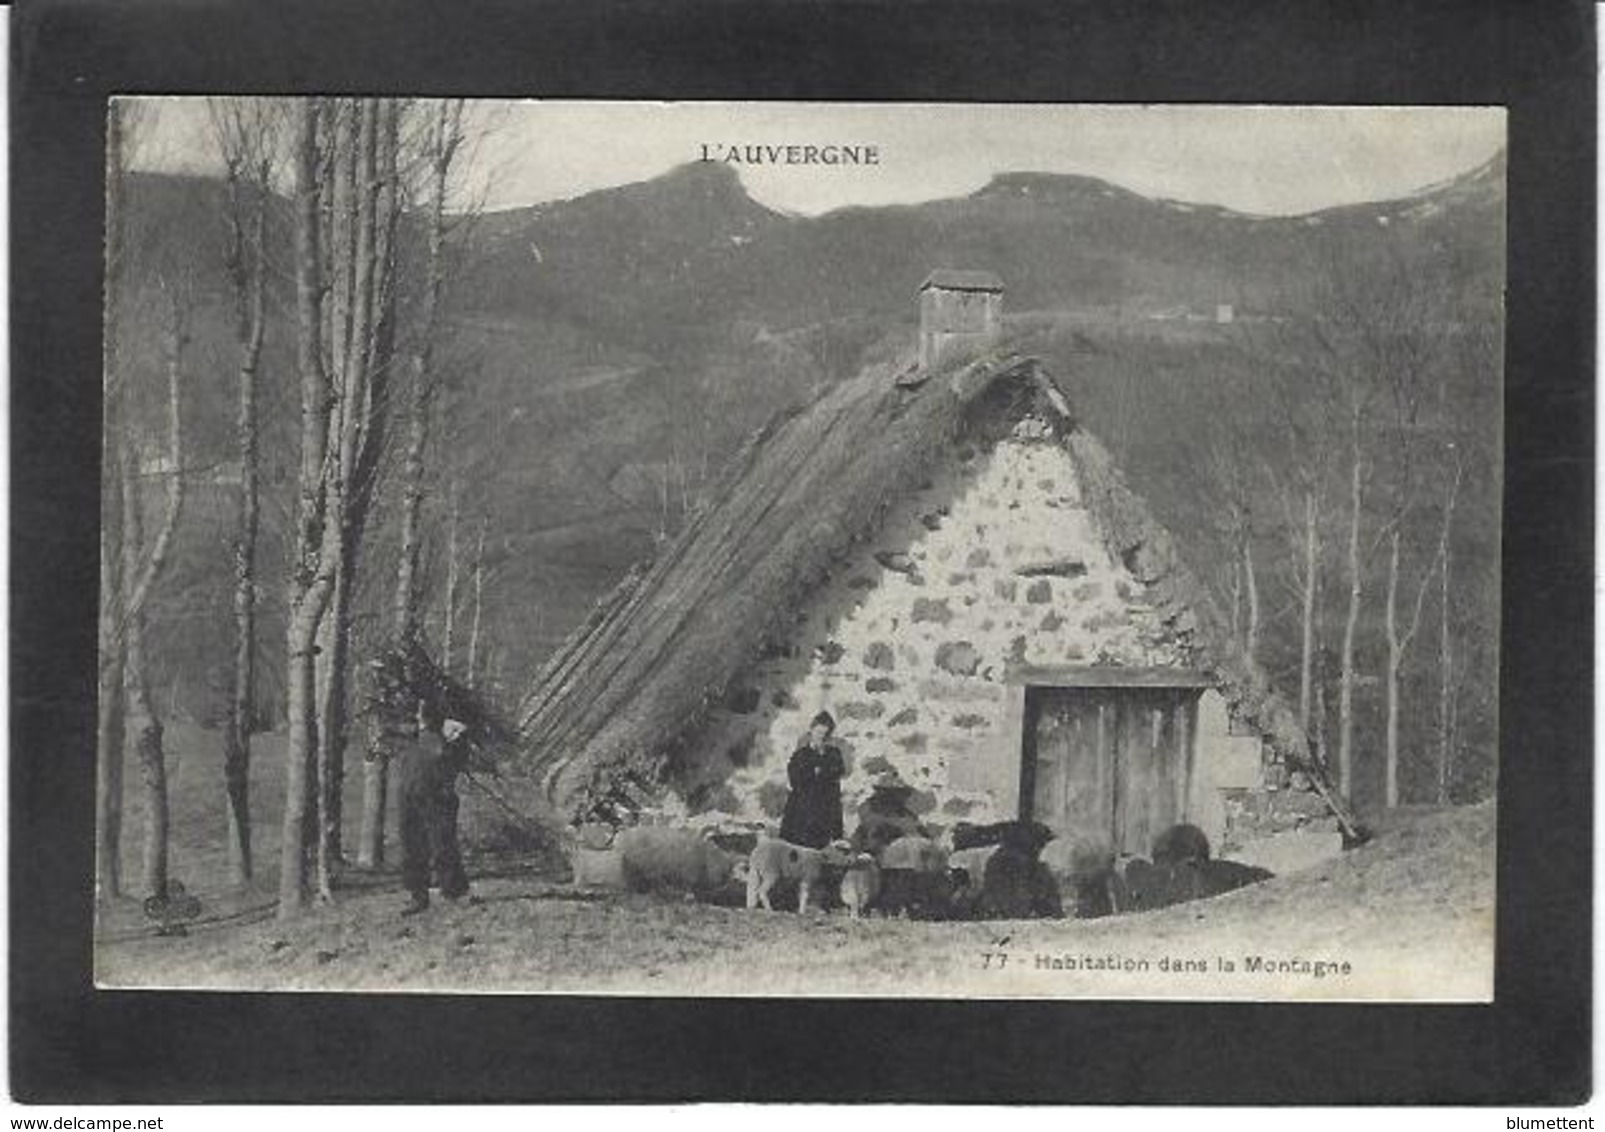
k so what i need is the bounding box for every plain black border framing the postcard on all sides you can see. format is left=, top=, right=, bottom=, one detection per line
left=10, top=0, right=1595, bottom=1105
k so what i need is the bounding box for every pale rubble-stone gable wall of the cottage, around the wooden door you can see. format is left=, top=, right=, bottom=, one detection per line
left=684, top=417, right=1225, bottom=825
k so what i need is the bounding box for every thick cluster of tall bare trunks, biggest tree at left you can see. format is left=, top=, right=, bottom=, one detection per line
left=279, top=92, right=400, bottom=915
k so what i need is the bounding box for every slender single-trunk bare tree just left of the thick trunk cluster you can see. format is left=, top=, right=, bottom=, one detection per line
left=210, top=98, right=278, bottom=885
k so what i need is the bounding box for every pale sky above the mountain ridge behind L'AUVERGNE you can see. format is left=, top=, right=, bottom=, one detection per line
left=135, top=98, right=1505, bottom=215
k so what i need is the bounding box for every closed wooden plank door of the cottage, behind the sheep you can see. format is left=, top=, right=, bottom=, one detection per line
left=1021, top=687, right=1197, bottom=856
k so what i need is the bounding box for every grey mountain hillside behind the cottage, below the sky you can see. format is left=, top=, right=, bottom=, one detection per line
left=113, top=156, right=1504, bottom=802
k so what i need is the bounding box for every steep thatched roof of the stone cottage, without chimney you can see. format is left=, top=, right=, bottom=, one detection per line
left=518, top=343, right=1354, bottom=828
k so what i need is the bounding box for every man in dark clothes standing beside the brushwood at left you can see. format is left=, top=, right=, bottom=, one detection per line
left=401, top=702, right=469, bottom=915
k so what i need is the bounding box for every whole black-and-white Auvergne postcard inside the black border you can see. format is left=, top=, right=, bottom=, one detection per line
left=95, top=96, right=1505, bottom=1002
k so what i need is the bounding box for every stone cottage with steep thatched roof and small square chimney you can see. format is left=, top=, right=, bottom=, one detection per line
left=520, top=273, right=1347, bottom=867
